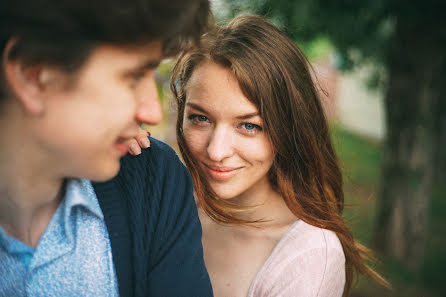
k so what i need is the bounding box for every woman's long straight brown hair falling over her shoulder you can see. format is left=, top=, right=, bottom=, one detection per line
left=171, top=16, right=388, bottom=296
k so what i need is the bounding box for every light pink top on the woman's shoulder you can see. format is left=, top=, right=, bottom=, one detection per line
left=248, top=220, right=345, bottom=297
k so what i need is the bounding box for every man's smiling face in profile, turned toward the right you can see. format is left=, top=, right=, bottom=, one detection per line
left=32, top=42, right=162, bottom=180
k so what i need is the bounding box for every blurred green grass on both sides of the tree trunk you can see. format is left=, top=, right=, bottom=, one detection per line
left=332, top=126, right=446, bottom=297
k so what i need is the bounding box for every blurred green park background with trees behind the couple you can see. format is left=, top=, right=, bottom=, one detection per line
left=146, top=0, right=446, bottom=297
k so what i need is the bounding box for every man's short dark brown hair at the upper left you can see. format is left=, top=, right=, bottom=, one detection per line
left=0, top=0, right=210, bottom=98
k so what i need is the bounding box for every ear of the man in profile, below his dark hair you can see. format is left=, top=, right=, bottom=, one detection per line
left=2, top=39, right=60, bottom=115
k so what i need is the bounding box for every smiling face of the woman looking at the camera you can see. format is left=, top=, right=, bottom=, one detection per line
left=183, top=62, right=274, bottom=199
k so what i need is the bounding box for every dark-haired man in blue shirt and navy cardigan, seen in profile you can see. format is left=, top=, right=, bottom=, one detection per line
left=0, top=0, right=212, bottom=297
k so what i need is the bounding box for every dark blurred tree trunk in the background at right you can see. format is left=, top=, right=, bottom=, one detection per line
left=375, top=21, right=446, bottom=271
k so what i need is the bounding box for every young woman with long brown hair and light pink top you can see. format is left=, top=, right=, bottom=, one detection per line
left=132, top=16, right=386, bottom=297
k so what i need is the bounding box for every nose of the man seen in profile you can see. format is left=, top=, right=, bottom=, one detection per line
left=135, top=75, right=163, bottom=125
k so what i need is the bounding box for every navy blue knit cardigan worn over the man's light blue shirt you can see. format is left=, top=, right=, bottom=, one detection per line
left=93, top=138, right=212, bottom=297
